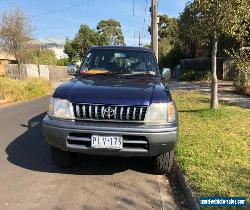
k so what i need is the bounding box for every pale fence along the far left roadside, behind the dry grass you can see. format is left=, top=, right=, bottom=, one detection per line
left=2, top=64, right=71, bottom=82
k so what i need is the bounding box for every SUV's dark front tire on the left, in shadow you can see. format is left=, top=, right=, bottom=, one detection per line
left=50, top=146, right=77, bottom=168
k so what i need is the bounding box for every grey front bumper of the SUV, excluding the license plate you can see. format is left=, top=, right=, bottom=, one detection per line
left=43, top=116, right=178, bottom=156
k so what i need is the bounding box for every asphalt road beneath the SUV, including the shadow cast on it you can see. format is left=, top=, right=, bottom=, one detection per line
left=0, top=97, right=177, bottom=210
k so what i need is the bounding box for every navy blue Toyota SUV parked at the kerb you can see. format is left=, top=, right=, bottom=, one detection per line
left=43, top=46, right=178, bottom=174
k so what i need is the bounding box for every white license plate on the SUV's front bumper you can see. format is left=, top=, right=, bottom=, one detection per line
left=91, top=135, right=123, bottom=149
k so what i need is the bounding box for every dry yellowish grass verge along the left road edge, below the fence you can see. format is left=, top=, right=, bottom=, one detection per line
left=0, top=77, right=52, bottom=102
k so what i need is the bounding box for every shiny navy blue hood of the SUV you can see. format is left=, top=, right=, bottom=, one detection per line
left=53, top=77, right=172, bottom=106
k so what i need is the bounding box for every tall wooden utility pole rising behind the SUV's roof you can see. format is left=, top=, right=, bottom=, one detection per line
left=151, top=0, right=159, bottom=60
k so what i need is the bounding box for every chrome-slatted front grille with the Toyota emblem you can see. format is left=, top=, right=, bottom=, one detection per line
left=73, top=104, right=147, bottom=122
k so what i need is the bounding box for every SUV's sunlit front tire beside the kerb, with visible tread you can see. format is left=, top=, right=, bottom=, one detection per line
left=154, top=150, right=174, bottom=174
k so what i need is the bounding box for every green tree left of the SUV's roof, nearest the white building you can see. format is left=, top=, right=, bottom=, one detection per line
left=64, top=25, right=99, bottom=62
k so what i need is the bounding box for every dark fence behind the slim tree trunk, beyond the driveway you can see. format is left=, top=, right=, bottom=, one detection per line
left=172, top=57, right=234, bottom=80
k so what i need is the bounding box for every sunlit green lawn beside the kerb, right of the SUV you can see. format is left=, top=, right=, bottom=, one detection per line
left=173, top=91, right=250, bottom=200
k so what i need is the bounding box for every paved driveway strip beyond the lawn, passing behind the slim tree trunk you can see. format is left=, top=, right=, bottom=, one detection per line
left=167, top=81, right=250, bottom=109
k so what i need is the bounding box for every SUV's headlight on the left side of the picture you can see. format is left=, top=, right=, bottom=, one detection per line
left=48, top=97, right=75, bottom=120
